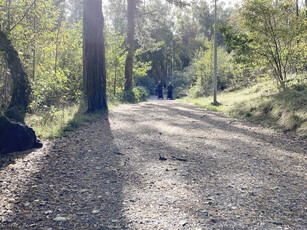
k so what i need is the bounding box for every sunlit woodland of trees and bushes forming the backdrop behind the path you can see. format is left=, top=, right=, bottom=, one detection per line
left=0, top=0, right=307, bottom=144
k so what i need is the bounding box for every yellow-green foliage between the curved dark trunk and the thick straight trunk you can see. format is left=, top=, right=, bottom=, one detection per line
left=0, top=0, right=82, bottom=112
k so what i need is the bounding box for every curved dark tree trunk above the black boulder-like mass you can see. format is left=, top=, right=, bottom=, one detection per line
left=0, top=29, right=30, bottom=123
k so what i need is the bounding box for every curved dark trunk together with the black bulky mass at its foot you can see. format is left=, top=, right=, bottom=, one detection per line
left=0, top=28, right=42, bottom=155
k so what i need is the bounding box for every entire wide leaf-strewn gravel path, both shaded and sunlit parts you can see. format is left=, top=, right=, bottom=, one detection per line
left=0, top=100, right=307, bottom=230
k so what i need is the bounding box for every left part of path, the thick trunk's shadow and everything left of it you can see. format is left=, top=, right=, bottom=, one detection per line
left=0, top=117, right=131, bottom=230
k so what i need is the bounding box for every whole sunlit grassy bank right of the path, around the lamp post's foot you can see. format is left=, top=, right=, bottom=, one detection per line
left=179, top=77, right=307, bottom=138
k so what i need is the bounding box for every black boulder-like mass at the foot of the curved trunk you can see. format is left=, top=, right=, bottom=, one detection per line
left=0, top=116, right=43, bottom=154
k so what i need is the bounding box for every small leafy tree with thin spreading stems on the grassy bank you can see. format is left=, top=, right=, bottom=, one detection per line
left=239, top=0, right=307, bottom=87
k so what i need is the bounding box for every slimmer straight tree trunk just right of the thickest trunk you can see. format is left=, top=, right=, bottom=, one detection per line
left=125, top=0, right=136, bottom=91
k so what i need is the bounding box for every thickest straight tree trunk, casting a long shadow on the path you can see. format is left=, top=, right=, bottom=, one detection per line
left=83, top=0, right=108, bottom=113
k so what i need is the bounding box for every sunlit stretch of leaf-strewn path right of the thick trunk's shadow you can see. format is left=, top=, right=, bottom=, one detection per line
left=111, top=101, right=307, bottom=229
